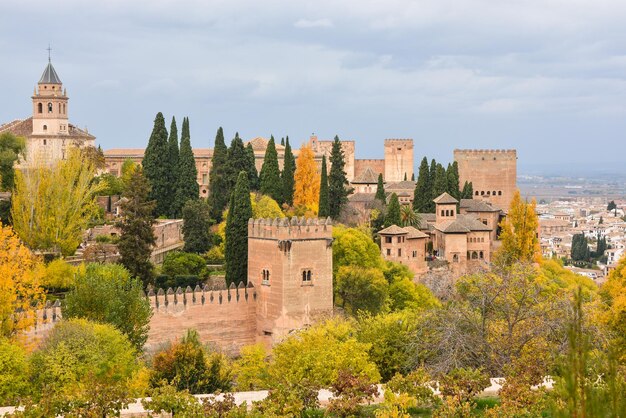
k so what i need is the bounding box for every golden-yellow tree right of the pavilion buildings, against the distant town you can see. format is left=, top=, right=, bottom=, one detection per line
left=494, top=190, right=541, bottom=265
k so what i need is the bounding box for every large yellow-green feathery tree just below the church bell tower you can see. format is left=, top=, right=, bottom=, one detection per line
left=11, top=150, right=106, bottom=256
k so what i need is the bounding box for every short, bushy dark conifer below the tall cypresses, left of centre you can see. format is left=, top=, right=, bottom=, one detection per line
left=183, top=199, right=211, bottom=254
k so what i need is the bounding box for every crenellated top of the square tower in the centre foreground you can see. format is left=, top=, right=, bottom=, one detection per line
left=248, top=216, right=333, bottom=241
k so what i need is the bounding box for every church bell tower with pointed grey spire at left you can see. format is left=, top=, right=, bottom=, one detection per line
left=32, top=56, right=68, bottom=136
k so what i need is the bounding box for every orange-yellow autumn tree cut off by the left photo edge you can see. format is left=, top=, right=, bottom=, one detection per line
left=0, top=225, right=44, bottom=337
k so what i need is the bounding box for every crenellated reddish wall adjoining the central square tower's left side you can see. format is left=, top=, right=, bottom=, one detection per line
left=146, top=283, right=257, bottom=354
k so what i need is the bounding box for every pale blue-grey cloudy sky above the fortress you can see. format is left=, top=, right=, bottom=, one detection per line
left=0, top=0, right=626, bottom=171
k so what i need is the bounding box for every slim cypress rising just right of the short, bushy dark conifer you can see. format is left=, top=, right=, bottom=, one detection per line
left=209, top=127, right=230, bottom=223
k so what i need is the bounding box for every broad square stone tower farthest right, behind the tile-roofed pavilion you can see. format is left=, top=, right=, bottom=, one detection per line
left=454, top=149, right=517, bottom=212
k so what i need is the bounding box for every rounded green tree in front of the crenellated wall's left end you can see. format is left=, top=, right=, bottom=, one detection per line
left=63, top=263, right=152, bottom=352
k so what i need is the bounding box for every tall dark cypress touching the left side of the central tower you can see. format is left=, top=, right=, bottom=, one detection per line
left=224, top=171, right=252, bottom=286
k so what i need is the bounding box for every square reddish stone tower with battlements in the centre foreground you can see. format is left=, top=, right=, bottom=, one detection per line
left=248, top=217, right=333, bottom=346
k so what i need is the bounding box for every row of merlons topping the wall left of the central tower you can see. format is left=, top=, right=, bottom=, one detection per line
left=147, top=282, right=256, bottom=313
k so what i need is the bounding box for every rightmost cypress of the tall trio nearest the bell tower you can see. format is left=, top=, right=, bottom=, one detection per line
left=173, top=118, right=200, bottom=218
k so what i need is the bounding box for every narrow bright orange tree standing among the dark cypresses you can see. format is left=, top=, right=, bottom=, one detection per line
left=293, top=145, right=320, bottom=214
